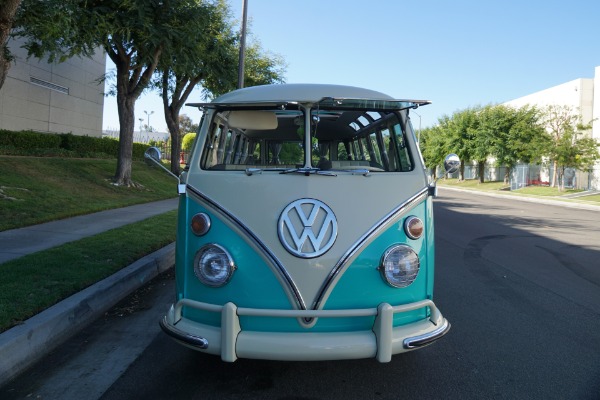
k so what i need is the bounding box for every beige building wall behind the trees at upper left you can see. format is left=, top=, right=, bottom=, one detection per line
left=0, top=40, right=106, bottom=137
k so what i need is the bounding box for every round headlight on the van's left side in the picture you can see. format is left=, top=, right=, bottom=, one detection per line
left=194, top=244, right=235, bottom=287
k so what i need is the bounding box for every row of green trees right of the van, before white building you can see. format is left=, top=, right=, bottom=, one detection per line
left=421, top=101, right=600, bottom=185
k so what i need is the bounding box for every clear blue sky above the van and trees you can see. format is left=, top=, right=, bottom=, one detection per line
left=104, top=0, right=600, bottom=131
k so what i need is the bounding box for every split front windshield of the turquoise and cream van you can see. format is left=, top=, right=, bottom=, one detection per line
left=201, top=101, right=413, bottom=172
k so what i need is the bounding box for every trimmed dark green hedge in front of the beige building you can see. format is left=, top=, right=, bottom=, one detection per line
left=0, top=129, right=148, bottom=159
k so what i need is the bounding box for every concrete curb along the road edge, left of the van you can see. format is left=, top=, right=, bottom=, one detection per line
left=0, top=243, right=175, bottom=386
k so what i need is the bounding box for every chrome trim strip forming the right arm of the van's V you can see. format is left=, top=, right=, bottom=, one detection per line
left=311, top=187, right=429, bottom=310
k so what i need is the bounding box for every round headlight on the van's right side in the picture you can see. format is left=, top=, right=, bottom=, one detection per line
left=379, top=244, right=420, bottom=288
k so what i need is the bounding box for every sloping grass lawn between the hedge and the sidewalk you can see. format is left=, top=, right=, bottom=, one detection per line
left=0, top=156, right=177, bottom=231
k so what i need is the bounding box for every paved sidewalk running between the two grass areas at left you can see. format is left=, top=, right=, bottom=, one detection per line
left=0, top=198, right=178, bottom=264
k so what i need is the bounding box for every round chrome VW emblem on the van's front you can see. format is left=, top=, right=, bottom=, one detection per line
left=277, top=199, right=337, bottom=258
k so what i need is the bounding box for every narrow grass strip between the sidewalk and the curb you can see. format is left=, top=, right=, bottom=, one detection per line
left=0, top=211, right=177, bottom=332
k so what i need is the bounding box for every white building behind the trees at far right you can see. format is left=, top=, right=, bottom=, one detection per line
left=504, top=66, right=600, bottom=190
